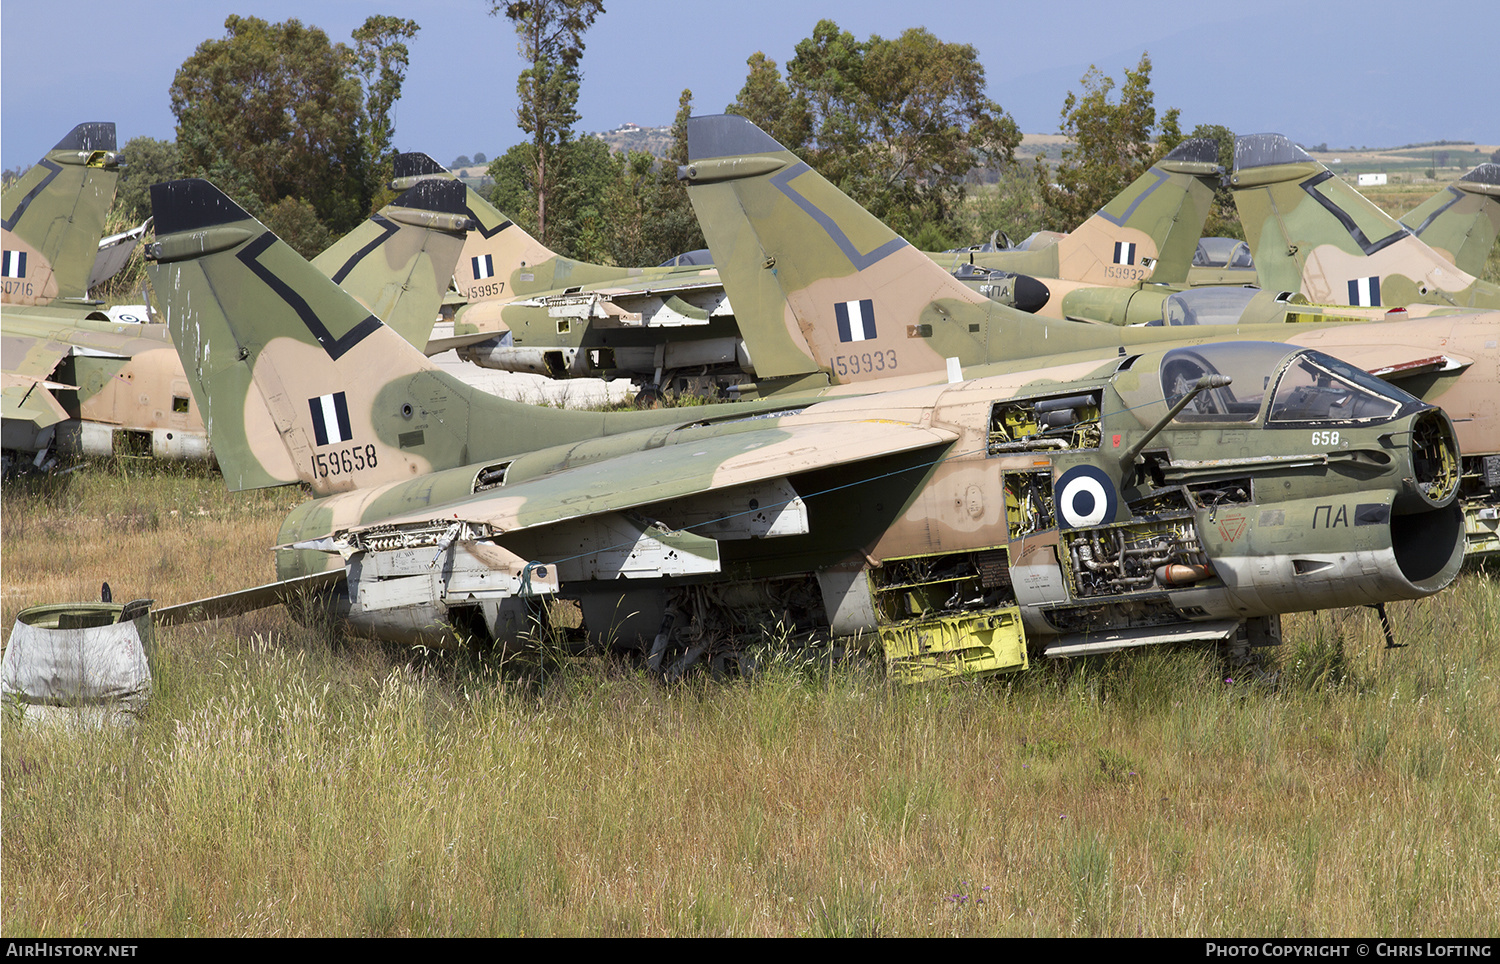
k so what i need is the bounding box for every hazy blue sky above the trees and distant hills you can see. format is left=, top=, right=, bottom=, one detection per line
left=0, top=0, right=1500, bottom=168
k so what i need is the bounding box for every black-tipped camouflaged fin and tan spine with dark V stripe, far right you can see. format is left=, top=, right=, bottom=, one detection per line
left=1230, top=133, right=1500, bottom=309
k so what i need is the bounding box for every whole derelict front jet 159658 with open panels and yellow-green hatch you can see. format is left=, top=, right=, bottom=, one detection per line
left=149, top=181, right=1463, bottom=681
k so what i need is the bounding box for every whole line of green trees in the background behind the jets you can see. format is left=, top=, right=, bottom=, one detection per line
left=8, top=0, right=1238, bottom=265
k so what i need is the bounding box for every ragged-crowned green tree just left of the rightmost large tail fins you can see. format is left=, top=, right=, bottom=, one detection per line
left=1038, top=54, right=1182, bottom=231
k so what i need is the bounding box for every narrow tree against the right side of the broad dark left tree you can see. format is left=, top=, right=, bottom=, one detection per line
left=351, top=15, right=422, bottom=210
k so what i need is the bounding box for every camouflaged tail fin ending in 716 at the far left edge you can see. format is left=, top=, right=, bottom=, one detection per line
left=0, top=121, right=123, bottom=304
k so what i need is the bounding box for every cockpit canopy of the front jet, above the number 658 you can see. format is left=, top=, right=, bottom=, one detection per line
left=1160, top=342, right=1424, bottom=429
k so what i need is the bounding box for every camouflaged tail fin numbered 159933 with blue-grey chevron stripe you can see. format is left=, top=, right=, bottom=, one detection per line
left=678, top=114, right=1031, bottom=382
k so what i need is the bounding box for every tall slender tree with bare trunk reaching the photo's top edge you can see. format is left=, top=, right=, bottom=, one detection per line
left=489, top=0, right=605, bottom=249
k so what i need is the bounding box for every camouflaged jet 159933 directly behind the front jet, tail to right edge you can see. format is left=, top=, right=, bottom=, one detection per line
left=680, top=115, right=1500, bottom=552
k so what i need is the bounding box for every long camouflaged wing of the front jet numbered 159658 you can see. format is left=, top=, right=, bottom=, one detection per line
left=340, top=420, right=959, bottom=534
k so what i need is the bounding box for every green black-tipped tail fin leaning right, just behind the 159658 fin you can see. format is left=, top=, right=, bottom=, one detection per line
left=312, top=178, right=474, bottom=348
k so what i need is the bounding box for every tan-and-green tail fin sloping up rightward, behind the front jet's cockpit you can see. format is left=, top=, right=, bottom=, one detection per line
left=1058, top=138, right=1224, bottom=285
